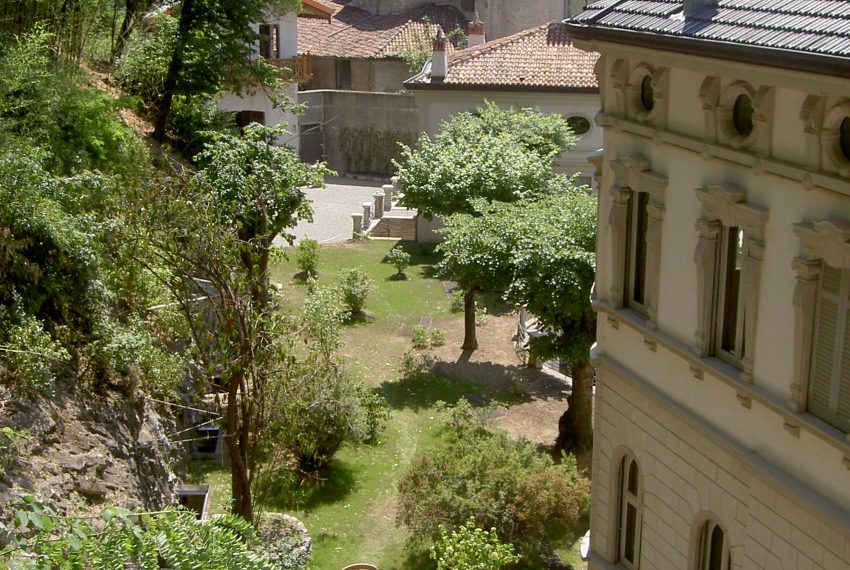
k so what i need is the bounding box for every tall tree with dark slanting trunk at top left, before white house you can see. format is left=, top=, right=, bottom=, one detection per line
left=153, top=0, right=300, bottom=141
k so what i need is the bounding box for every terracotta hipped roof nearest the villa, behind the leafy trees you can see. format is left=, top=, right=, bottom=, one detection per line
left=405, top=22, right=599, bottom=91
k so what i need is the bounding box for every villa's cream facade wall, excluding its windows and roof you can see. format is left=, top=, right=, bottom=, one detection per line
left=578, top=35, right=850, bottom=569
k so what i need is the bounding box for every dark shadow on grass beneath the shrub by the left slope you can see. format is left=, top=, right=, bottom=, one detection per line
left=255, top=459, right=357, bottom=513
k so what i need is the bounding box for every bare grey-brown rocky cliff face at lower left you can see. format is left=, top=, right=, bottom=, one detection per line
left=0, top=380, right=185, bottom=514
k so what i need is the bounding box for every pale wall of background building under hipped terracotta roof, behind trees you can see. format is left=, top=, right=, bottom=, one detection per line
left=413, top=89, right=602, bottom=176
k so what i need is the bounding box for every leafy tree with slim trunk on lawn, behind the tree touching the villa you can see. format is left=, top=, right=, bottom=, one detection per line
left=395, top=103, right=575, bottom=350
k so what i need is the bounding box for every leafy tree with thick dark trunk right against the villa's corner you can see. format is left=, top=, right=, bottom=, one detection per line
left=439, top=190, right=596, bottom=451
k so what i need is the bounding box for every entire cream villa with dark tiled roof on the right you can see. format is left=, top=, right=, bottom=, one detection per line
left=567, top=0, right=850, bottom=570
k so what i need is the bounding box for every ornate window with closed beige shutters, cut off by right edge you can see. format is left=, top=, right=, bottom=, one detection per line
left=791, top=221, right=850, bottom=433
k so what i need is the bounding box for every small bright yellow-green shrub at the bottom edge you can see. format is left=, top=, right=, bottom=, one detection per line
left=431, top=519, right=520, bottom=570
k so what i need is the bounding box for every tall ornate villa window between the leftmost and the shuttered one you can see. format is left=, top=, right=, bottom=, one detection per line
left=694, top=185, right=767, bottom=382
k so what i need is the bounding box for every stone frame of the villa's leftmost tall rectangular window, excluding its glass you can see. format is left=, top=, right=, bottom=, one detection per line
left=608, top=155, right=668, bottom=330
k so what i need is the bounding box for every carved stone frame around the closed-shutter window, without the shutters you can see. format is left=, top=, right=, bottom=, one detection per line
left=790, top=219, right=850, bottom=426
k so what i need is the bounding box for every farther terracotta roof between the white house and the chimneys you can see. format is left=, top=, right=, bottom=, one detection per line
left=298, top=0, right=466, bottom=59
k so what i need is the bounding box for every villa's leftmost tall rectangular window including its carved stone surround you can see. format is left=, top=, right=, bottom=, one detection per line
left=608, top=156, right=667, bottom=328
